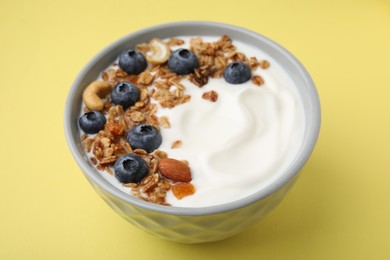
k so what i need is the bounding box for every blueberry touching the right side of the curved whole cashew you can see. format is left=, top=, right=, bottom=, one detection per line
left=111, top=81, right=140, bottom=109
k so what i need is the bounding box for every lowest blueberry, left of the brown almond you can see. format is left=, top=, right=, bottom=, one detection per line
left=114, top=154, right=149, bottom=183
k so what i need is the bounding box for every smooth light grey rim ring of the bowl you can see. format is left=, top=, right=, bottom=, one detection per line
left=64, top=21, right=321, bottom=216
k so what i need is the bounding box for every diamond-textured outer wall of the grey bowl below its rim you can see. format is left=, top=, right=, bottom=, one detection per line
left=90, top=173, right=294, bottom=244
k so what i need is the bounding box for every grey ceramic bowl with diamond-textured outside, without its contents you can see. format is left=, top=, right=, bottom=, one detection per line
left=64, top=21, right=321, bottom=243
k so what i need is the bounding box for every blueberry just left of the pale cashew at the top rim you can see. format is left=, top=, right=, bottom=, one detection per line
left=118, top=50, right=148, bottom=75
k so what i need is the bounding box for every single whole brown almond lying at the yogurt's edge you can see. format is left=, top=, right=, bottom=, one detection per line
left=158, top=158, right=192, bottom=182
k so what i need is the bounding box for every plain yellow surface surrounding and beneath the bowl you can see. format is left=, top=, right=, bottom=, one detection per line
left=0, top=0, right=390, bottom=260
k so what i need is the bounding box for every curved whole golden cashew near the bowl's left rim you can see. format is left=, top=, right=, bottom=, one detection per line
left=83, top=81, right=111, bottom=111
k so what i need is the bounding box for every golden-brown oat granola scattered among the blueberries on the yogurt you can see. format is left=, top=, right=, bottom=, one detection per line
left=81, top=35, right=270, bottom=205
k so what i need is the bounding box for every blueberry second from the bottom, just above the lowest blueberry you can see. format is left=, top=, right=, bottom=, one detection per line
left=127, top=124, right=162, bottom=153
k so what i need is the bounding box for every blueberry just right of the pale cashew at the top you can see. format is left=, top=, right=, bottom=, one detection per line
left=168, top=49, right=199, bottom=75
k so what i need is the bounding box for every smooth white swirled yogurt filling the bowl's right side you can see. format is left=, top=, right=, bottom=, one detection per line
left=84, top=37, right=305, bottom=207
